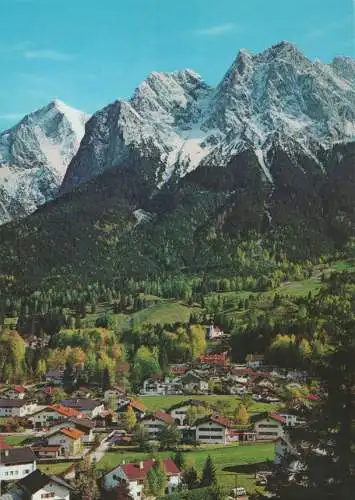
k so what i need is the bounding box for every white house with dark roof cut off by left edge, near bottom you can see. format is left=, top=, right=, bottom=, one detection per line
left=0, top=447, right=37, bottom=482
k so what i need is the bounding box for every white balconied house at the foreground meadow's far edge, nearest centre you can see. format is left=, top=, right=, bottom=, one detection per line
left=195, top=416, right=234, bottom=444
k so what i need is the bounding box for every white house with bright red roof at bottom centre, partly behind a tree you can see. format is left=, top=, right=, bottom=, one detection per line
left=103, top=458, right=181, bottom=500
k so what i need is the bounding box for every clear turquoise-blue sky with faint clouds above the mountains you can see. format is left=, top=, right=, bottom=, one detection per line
left=0, top=0, right=355, bottom=130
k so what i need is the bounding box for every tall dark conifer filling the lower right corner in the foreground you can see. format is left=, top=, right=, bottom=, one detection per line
left=270, top=281, right=355, bottom=500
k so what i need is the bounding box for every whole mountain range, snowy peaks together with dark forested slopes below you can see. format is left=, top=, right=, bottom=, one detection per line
left=0, top=42, right=355, bottom=292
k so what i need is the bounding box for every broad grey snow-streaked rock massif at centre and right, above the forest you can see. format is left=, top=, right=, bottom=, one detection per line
left=61, top=42, right=355, bottom=194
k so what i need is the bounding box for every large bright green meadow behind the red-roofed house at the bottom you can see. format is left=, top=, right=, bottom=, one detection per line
left=98, top=443, right=274, bottom=493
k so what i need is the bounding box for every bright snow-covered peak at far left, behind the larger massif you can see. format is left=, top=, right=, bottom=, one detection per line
left=0, top=100, right=89, bottom=224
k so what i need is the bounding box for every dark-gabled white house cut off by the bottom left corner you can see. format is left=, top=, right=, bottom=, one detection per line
left=0, top=469, right=73, bottom=500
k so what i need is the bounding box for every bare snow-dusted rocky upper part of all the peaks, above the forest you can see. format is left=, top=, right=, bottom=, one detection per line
left=0, top=42, right=355, bottom=226
